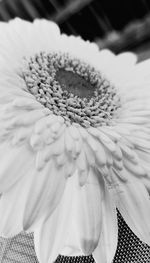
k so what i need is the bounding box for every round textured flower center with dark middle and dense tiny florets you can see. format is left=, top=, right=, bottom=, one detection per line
left=23, top=52, right=120, bottom=127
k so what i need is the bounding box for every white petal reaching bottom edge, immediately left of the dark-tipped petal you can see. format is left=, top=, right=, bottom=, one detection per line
left=34, top=172, right=76, bottom=263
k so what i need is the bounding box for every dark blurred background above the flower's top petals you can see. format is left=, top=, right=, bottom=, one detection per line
left=0, top=0, right=150, bottom=60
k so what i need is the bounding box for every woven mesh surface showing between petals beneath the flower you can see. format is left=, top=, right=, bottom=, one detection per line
left=0, top=213, right=150, bottom=263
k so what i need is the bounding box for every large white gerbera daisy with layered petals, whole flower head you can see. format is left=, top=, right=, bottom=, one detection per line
left=0, top=19, right=150, bottom=263
